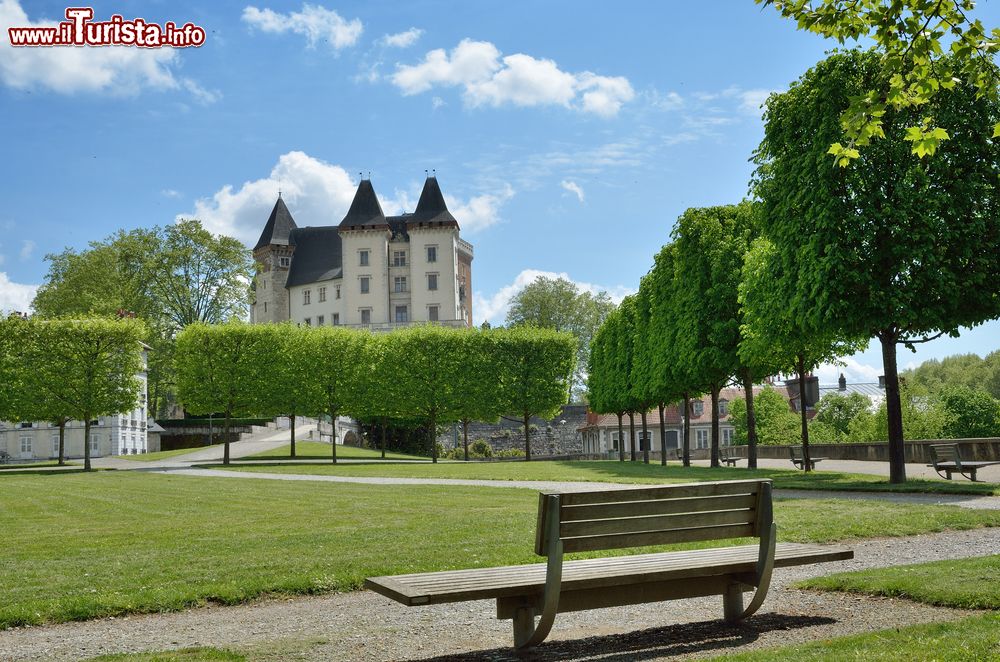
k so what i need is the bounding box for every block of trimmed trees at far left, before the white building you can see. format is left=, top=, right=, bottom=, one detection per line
left=0, top=315, right=146, bottom=471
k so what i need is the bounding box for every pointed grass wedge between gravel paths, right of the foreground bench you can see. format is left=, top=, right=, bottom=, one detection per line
left=799, top=555, right=1000, bottom=609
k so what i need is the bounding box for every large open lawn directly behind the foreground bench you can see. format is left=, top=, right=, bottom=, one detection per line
left=0, top=471, right=1000, bottom=629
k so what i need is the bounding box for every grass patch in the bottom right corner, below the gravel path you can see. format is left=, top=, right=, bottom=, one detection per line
left=712, top=613, right=1000, bottom=662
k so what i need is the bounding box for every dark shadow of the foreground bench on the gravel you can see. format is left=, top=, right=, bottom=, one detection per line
left=413, top=614, right=836, bottom=662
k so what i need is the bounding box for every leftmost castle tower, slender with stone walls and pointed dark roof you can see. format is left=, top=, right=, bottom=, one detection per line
left=250, top=193, right=296, bottom=324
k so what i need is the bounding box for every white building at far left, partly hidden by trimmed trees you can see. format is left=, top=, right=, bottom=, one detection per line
left=0, top=345, right=148, bottom=460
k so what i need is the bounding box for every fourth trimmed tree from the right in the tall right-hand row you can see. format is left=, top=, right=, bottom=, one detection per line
left=674, top=202, right=753, bottom=467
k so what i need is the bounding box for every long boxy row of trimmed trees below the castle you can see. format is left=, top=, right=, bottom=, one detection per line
left=176, top=322, right=576, bottom=464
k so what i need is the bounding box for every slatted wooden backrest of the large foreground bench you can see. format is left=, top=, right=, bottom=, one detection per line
left=535, top=480, right=772, bottom=556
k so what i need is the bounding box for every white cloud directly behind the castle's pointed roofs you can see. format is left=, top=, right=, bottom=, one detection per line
left=184, top=151, right=514, bottom=246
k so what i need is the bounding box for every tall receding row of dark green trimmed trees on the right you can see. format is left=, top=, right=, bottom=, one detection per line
left=589, top=51, right=1000, bottom=482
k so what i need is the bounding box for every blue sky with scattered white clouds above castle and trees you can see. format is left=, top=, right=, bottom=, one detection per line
left=0, top=0, right=1000, bottom=383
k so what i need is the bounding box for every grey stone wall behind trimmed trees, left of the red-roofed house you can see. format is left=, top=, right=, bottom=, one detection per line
left=438, top=405, right=587, bottom=457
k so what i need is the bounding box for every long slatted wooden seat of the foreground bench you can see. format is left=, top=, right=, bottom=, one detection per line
left=365, top=543, right=854, bottom=605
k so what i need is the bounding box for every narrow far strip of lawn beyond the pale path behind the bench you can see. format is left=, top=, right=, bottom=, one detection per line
left=207, top=460, right=1000, bottom=495
